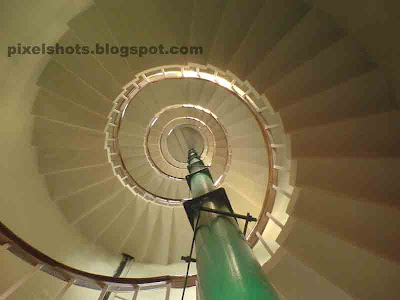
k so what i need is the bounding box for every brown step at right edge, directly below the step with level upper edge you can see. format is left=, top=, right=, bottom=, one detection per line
left=290, top=187, right=400, bottom=263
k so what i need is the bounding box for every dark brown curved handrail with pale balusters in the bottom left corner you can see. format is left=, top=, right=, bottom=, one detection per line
left=0, top=222, right=196, bottom=300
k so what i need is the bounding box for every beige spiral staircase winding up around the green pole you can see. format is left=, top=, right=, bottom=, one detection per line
left=0, top=0, right=400, bottom=300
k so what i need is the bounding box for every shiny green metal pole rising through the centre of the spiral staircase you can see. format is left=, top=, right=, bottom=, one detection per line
left=188, top=149, right=279, bottom=300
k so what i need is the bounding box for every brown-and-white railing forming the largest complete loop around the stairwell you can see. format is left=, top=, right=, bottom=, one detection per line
left=104, top=64, right=284, bottom=251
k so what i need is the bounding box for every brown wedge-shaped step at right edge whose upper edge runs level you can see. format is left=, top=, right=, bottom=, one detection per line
left=296, top=158, right=400, bottom=207
